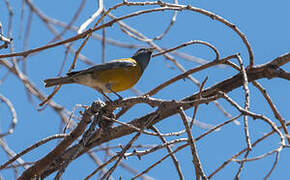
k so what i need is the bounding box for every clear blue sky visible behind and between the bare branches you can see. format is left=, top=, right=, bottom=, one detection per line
left=0, top=0, right=290, bottom=179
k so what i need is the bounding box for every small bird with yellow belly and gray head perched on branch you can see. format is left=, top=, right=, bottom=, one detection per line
left=44, top=48, right=155, bottom=101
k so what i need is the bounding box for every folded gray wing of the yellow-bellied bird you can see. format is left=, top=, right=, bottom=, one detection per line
left=67, top=58, right=136, bottom=76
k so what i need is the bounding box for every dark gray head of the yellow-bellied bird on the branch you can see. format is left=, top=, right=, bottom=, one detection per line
left=132, top=48, right=154, bottom=72
